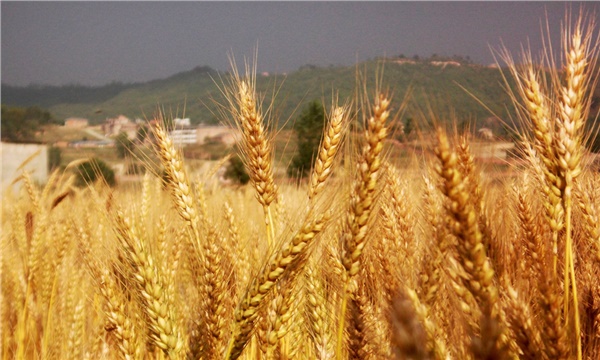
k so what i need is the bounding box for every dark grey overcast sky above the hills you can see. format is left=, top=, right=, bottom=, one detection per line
left=0, top=1, right=600, bottom=86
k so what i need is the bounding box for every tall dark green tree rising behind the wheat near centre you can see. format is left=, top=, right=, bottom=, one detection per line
left=288, top=100, right=325, bottom=178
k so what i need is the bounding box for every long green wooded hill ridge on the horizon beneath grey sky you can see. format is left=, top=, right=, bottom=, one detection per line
left=2, top=58, right=510, bottom=131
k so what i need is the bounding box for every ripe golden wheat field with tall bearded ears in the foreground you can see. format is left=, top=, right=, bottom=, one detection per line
left=0, top=11, right=600, bottom=360
